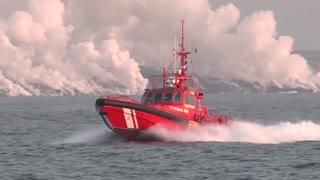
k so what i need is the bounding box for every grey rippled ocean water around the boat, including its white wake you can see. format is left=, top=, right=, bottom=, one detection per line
left=0, top=93, right=320, bottom=180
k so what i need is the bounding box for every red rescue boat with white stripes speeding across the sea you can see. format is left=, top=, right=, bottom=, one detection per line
left=95, top=20, right=232, bottom=141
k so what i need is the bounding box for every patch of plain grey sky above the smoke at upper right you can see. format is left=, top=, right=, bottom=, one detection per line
left=210, top=0, right=320, bottom=50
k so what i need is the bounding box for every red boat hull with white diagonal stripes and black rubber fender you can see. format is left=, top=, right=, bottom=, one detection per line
left=96, top=99, right=190, bottom=141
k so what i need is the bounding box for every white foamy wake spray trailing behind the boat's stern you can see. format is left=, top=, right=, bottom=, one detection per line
left=148, top=120, right=320, bottom=144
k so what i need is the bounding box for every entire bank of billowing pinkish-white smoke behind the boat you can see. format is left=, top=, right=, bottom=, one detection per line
left=0, top=0, right=320, bottom=95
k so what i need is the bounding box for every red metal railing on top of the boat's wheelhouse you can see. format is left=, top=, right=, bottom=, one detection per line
left=149, top=73, right=201, bottom=91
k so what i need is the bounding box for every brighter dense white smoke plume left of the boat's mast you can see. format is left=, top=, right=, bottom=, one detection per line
left=0, top=0, right=147, bottom=95
